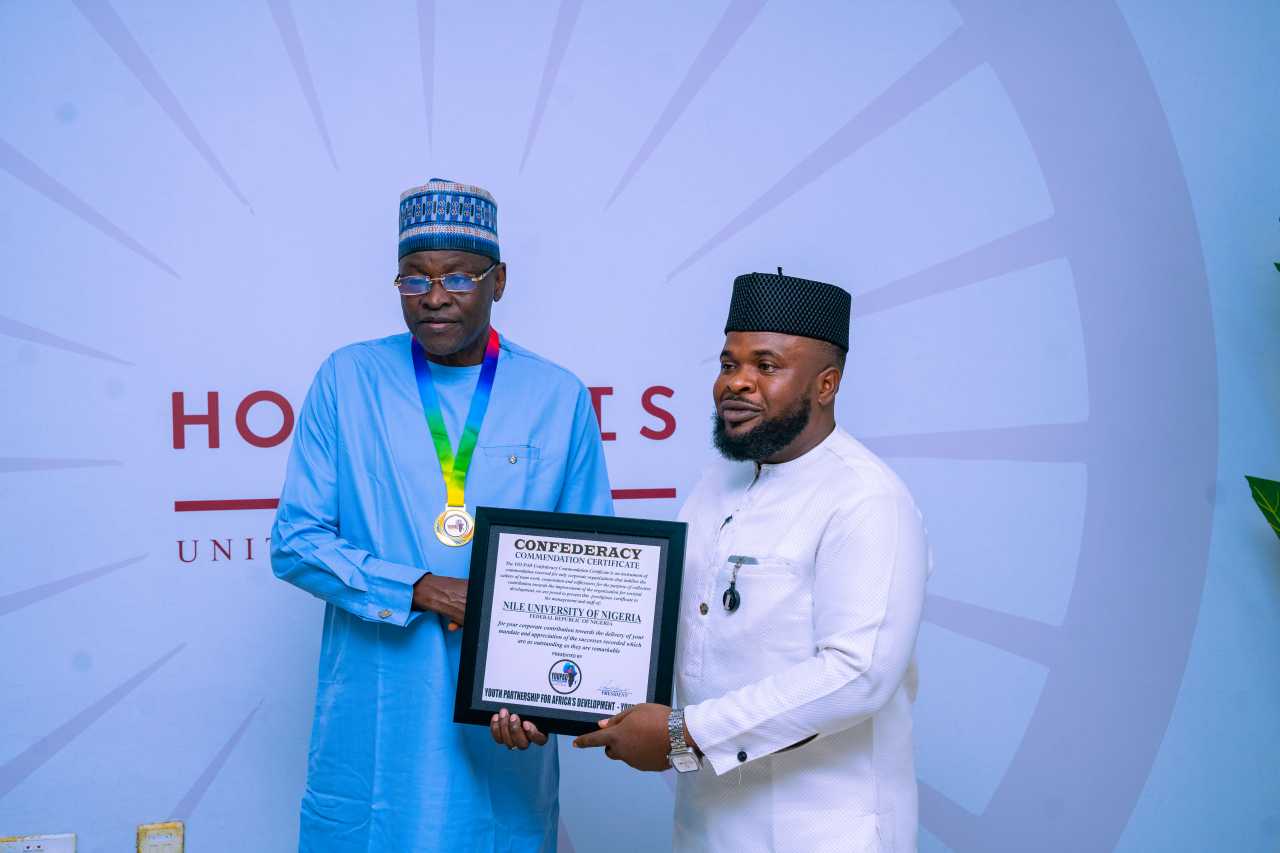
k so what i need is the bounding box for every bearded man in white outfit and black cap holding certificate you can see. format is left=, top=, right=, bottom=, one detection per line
left=573, top=269, right=931, bottom=853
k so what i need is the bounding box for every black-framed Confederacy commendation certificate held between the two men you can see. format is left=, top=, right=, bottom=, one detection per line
left=453, top=506, right=685, bottom=735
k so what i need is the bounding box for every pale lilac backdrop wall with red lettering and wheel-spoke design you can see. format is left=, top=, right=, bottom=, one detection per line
left=0, top=0, right=1280, bottom=852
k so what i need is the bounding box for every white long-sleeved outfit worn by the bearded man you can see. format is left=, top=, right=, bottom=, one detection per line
left=675, top=428, right=931, bottom=853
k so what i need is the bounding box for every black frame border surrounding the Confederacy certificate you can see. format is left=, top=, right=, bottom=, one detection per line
left=453, top=506, right=687, bottom=735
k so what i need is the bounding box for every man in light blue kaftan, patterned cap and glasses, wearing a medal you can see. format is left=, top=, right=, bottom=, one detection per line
left=271, top=175, right=613, bottom=853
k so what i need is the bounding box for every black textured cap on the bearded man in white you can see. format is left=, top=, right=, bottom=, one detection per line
left=724, top=269, right=852, bottom=350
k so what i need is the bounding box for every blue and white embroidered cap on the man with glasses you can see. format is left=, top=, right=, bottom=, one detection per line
left=397, top=178, right=502, bottom=261
